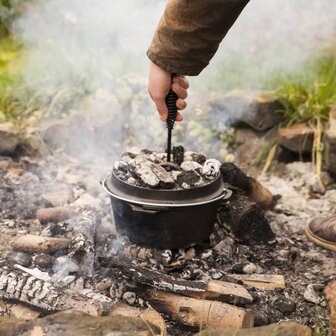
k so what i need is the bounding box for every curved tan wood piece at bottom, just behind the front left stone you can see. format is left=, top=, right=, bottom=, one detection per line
left=108, top=302, right=167, bottom=336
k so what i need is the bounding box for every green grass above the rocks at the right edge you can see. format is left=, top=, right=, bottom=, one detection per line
left=270, top=47, right=336, bottom=126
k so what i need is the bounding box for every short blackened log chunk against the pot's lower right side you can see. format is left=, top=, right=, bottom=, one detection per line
left=218, top=191, right=275, bottom=243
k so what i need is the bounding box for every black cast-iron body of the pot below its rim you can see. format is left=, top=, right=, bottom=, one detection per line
left=111, top=196, right=221, bottom=249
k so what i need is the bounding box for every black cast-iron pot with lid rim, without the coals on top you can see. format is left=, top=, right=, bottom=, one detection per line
left=102, top=173, right=230, bottom=249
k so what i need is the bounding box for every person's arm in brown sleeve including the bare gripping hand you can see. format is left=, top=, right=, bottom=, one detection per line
left=147, top=0, right=249, bottom=121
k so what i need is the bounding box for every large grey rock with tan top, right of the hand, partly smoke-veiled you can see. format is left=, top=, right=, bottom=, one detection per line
left=210, top=90, right=284, bottom=131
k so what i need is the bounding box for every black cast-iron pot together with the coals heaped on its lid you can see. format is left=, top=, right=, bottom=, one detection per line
left=102, top=151, right=230, bottom=249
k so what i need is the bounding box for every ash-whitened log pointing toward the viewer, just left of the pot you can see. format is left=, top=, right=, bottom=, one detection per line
left=69, top=210, right=97, bottom=277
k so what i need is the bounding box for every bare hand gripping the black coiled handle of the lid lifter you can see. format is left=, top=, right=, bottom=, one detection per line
left=148, top=62, right=189, bottom=121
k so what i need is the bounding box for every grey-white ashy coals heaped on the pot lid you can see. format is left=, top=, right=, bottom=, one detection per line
left=113, top=150, right=220, bottom=190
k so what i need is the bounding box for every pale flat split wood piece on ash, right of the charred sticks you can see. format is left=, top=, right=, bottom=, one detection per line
left=230, top=274, right=286, bottom=288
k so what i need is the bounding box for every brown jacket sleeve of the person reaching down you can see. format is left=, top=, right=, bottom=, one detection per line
left=147, top=0, right=249, bottom=76
